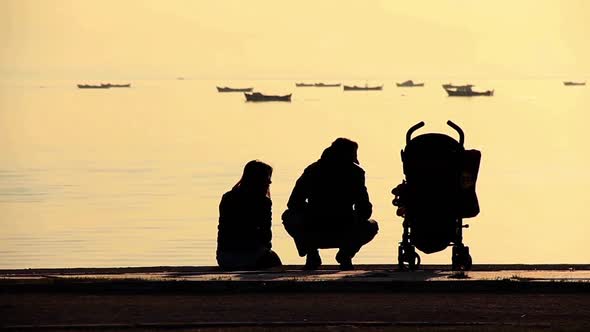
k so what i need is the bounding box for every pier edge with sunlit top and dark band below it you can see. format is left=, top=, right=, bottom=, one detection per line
left=0, top=264, right=590, bottom=294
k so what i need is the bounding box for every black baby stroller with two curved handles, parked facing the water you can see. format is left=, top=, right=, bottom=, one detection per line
left=391, top=121, right=481, bottom=270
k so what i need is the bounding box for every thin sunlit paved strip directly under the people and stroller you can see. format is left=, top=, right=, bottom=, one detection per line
left=0, top=264, right=590, bottom=282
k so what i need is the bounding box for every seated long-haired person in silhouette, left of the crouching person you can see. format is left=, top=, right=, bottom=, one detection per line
left=217, top=160, right=282, bottom=270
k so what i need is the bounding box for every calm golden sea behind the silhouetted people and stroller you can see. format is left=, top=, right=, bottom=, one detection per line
left=0, top=79, right=590, bottom=269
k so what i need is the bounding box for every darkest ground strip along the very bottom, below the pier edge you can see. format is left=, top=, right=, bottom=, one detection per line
left=0, top=293, right=590, bottom=331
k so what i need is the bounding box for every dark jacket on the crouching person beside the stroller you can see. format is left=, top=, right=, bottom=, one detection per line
left=287, top=157, right=373, bottom=229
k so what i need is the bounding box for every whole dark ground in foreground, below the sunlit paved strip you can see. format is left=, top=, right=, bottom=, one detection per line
left=0, top=267, right=590, bottom=331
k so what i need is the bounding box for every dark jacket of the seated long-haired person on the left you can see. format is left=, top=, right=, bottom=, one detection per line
left=217, top=188, right=272, bottom=250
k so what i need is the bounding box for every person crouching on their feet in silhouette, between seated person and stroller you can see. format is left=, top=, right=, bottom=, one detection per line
left=282, top=138, right=379, bottom=270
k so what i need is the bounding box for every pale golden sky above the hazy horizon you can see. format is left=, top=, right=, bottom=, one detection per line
left=0, top=0, right=590, bottom=79
